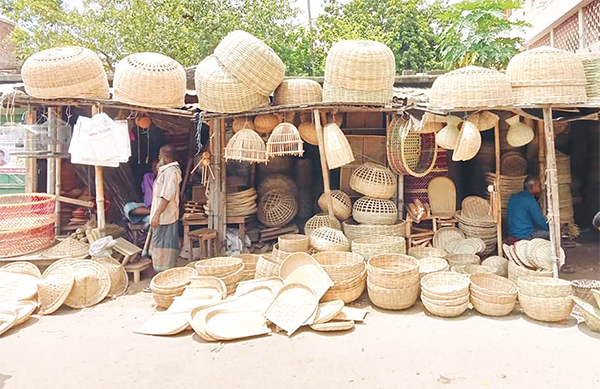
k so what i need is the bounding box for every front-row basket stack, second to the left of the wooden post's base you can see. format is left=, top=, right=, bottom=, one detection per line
left=470, top=274, right=517, bottom=316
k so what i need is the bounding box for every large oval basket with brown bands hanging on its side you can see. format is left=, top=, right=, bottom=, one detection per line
left=387, top=116, right=437, bottom=177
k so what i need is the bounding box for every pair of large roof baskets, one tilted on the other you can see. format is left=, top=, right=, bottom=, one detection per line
left=195, top=30, right=285, bottom=113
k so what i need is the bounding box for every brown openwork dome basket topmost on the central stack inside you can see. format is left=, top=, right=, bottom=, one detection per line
left=350, top=162, right=397, bottom=199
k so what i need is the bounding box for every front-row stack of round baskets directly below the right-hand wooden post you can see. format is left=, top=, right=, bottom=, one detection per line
left=517, top=277, right=573, bottom=322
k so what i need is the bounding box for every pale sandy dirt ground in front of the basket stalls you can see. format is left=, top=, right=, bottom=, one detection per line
left=0, top=235, right=600, bottom=389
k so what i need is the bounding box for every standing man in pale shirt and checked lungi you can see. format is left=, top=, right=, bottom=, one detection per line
left=150, top=145, right=181, bottom=272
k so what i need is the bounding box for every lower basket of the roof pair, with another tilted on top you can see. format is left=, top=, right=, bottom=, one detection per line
left=195, top=55, right=269, bottom=113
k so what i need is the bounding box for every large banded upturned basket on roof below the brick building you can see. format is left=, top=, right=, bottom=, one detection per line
left=506, top=46, right=587, bottom=104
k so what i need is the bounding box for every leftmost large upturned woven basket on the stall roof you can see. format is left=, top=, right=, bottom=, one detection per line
left=21, top=46, right=109, bottom=99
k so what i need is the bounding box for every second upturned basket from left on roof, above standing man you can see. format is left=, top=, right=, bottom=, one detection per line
left=113, top=53, right=187, bottom=108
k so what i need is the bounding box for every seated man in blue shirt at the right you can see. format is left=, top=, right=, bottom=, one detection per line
left=507, top=176, right=550, bottom=239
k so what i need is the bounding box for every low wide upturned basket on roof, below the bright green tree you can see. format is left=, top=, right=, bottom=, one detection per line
left=429, top=66, right=514, bottom=108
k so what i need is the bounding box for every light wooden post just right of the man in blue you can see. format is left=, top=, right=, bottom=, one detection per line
left=543, top=107, right=561, bottom=278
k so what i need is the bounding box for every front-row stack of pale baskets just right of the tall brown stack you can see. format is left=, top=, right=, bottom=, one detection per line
left=421, top=271, right=469, bottom=317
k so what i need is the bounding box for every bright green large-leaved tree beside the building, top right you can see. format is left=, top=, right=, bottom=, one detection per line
left=439, top=0, right=527, bottom=70
